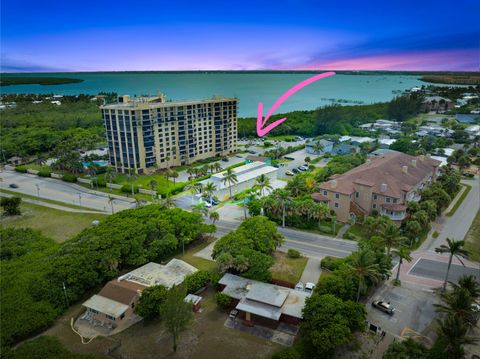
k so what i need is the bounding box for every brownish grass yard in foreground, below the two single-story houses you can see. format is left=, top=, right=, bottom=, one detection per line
left=43, top=288, right=284, bottom=359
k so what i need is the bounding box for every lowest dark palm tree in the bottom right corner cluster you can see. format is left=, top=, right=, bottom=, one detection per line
left=436, top=315, right=479, bottom=359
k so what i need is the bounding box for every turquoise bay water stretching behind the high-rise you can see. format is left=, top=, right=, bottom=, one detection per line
left=0, top=72, right=424, bottom=117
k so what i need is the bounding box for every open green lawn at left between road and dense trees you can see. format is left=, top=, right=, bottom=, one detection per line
left=1, top=202, right=107, bottom=242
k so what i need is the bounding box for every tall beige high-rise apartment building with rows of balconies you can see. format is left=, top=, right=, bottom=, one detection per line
left=100, top=95, right=238, bottom=173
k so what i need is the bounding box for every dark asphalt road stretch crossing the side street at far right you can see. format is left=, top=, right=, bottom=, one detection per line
left=410, top=258, right=480, bottom=282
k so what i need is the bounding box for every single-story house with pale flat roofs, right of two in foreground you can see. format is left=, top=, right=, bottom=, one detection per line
left=218, top=273, right=310, bottom=325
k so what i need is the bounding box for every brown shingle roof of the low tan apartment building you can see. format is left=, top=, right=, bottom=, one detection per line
left=320, top=152, right=440, bottom=198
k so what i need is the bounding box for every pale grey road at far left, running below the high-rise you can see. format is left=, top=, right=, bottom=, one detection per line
left=0, top=170, right=135, bottom=212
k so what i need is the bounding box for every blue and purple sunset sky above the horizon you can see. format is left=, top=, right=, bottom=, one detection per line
left=1, top=0, right=480, bottom=72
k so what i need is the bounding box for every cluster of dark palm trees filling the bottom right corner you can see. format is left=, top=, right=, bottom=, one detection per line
left=435, top=275, right=480, bottom=359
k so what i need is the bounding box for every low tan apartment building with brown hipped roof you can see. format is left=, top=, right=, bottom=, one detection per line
left=312, top=152, right=440, bottom=222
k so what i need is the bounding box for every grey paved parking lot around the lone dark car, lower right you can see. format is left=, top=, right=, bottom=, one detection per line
left=366, top=282, right=438, bottom=336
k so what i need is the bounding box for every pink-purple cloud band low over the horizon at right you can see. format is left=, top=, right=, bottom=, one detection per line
left=297, top=49, right=479, bottom=71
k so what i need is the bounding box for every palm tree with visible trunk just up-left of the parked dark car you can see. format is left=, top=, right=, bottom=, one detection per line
left=348, top=250, right=382, bottom=302
